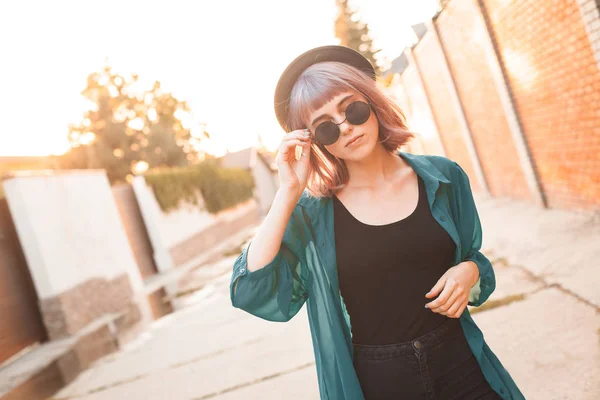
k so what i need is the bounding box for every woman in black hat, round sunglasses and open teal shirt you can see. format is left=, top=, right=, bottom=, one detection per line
left=230, top=46, right=524, bottom=400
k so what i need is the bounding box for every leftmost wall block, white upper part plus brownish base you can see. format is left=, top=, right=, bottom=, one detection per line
left=3, top=171, right=148, bottom=339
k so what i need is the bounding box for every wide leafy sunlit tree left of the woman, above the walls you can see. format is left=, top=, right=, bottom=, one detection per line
left=60, top=66, right=208, bottom=183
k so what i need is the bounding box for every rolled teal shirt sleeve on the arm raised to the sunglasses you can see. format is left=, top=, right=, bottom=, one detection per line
left=230, top=206, right=308, bottom=322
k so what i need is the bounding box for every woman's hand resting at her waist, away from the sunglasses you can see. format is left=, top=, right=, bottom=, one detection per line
left=425, top=261, right=479, bottom=318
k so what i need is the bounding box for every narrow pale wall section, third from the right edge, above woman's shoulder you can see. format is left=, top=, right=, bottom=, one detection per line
left=414, top=33, right=479, bottom=191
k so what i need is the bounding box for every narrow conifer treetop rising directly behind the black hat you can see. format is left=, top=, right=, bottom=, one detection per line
left=335, top=0, right=381, bottom=75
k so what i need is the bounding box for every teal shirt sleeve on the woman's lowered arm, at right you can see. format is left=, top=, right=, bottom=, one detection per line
left=454, top=162, right=496, bottom=307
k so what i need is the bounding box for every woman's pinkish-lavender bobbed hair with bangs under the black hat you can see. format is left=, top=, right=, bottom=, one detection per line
left=287, top=61, right=414, bottom=197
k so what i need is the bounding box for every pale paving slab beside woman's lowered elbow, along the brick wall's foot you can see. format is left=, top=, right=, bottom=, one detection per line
left=475, top=194, right=600, bottom=307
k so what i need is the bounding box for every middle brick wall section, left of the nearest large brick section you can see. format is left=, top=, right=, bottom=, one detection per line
left=435, top=0, right=532, bottom=200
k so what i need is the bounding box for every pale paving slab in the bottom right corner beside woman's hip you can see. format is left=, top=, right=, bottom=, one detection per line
left=473, top=288, right=600, bottom=400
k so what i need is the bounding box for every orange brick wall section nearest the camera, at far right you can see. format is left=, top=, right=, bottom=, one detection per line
left=482, top=0, right=600, bottom=208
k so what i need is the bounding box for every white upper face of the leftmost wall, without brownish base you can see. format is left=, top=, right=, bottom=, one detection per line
left=3, top=171, right=142, bottom=299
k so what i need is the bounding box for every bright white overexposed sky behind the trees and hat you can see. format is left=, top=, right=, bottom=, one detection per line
left=0, top=0, right=437, bottom=156
